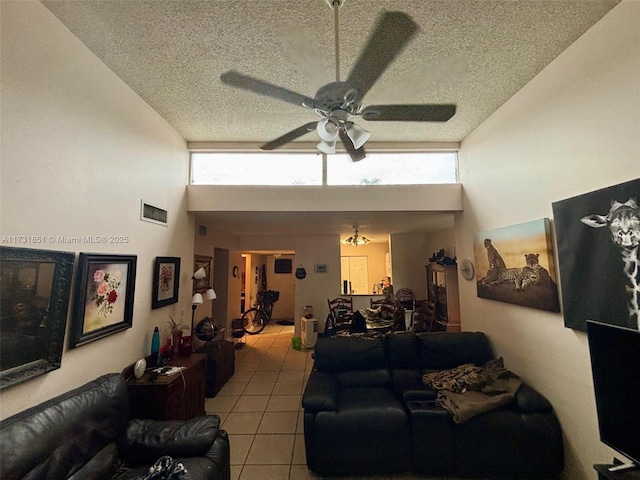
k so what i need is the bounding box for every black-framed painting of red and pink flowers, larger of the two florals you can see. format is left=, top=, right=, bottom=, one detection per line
left=69, top=253, right=137, bottom=348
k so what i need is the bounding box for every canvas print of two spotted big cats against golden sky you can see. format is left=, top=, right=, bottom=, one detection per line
left=474, top=218, right=560, bottom=312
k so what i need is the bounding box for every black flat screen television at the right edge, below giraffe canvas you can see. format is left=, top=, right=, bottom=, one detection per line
left=587, top=321, right=640, bottom=466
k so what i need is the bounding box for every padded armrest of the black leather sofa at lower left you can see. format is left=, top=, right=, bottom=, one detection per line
left=118, top=415, right=222, bottom=465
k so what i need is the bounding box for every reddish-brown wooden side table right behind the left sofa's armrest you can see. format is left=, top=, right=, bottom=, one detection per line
left=127, top=353, right=206, bottom=420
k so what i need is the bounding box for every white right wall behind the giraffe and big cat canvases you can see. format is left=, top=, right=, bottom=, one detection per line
left=455, top=0, right=640, bottom=480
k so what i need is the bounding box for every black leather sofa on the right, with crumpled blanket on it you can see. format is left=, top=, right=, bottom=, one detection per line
left=302, top=332, right=563, bottom=479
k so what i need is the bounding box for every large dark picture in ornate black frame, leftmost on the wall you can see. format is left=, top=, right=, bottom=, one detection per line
left=0, top=247, right=75, bottom=389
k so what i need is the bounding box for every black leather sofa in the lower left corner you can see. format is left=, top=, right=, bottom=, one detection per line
left=0, top=374, right=231, bottom=480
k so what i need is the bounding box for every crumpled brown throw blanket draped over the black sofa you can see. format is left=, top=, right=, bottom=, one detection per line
left=422, top=357, right=522, bottom=423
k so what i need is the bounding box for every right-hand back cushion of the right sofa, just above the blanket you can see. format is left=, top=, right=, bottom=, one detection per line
left=417, top=332, right=493, bottom=371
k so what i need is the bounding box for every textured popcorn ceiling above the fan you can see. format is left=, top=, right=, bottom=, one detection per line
left=42, top=0, right=619, bottom=142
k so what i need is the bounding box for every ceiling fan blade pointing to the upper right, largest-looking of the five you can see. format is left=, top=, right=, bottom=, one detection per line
left=346, top=12, right=418, bottom=100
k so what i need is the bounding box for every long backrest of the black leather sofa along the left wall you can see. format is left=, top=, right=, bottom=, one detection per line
left=0, top=374, right=129, bottom=479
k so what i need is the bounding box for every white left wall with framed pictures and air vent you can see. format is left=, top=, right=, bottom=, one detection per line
left=0, top=1, right=193, bottom=418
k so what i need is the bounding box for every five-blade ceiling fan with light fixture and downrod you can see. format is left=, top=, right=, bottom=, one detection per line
left=220, top=0, right=456, bottom=162
